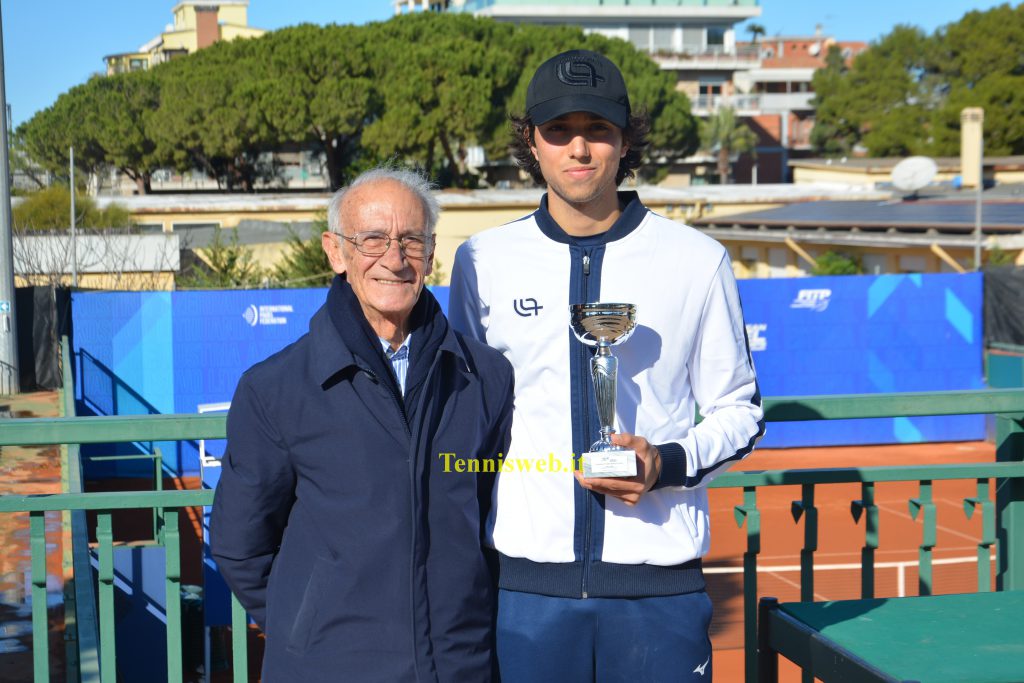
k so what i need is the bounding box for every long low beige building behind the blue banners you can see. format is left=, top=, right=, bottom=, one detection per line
left=75, top=182, right=1024, bottom=287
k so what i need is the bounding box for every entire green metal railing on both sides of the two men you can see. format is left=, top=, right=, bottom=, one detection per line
left=0, top=389, right=1024, bottom=683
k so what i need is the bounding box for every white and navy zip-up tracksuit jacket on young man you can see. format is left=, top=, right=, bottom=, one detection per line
left=449, top=193, right=764, bottom=597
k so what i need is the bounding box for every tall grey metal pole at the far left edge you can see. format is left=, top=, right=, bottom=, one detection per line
left=0, top=1, right=22, bottom=395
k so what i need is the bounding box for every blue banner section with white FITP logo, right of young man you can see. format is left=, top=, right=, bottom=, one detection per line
left=739, top=273, right=985, bottom=447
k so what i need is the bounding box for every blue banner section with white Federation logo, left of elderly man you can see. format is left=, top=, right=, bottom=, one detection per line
left=72, top=289, right=327, bottom=478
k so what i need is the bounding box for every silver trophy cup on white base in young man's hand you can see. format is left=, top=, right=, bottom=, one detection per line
left=569, top=303, right=637, bottom=478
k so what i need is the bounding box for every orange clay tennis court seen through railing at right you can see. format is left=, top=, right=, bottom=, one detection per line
left=705, top=441, right=995, bottom=683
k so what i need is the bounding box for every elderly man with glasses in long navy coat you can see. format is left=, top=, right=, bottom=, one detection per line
left=211, top=168, right=512, bottom=683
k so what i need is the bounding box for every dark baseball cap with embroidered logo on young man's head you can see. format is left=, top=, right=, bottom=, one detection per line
left=526, top=50, right=630, bottom=128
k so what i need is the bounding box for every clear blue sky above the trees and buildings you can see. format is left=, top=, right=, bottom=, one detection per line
left=0, top=0, right=1000, bottom=126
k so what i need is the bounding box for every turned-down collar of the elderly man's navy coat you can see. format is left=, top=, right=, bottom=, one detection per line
left=309, top=275, right=472, bottom=390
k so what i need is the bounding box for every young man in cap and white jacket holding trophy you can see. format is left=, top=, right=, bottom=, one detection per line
left=450, top=50, right=764, bottom=683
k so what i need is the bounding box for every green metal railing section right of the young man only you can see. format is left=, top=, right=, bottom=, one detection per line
left=710, top=389, right=1024, bottom=682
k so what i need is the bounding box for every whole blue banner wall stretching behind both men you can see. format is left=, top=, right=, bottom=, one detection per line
left=72, top=273, right=984, bottom=476
